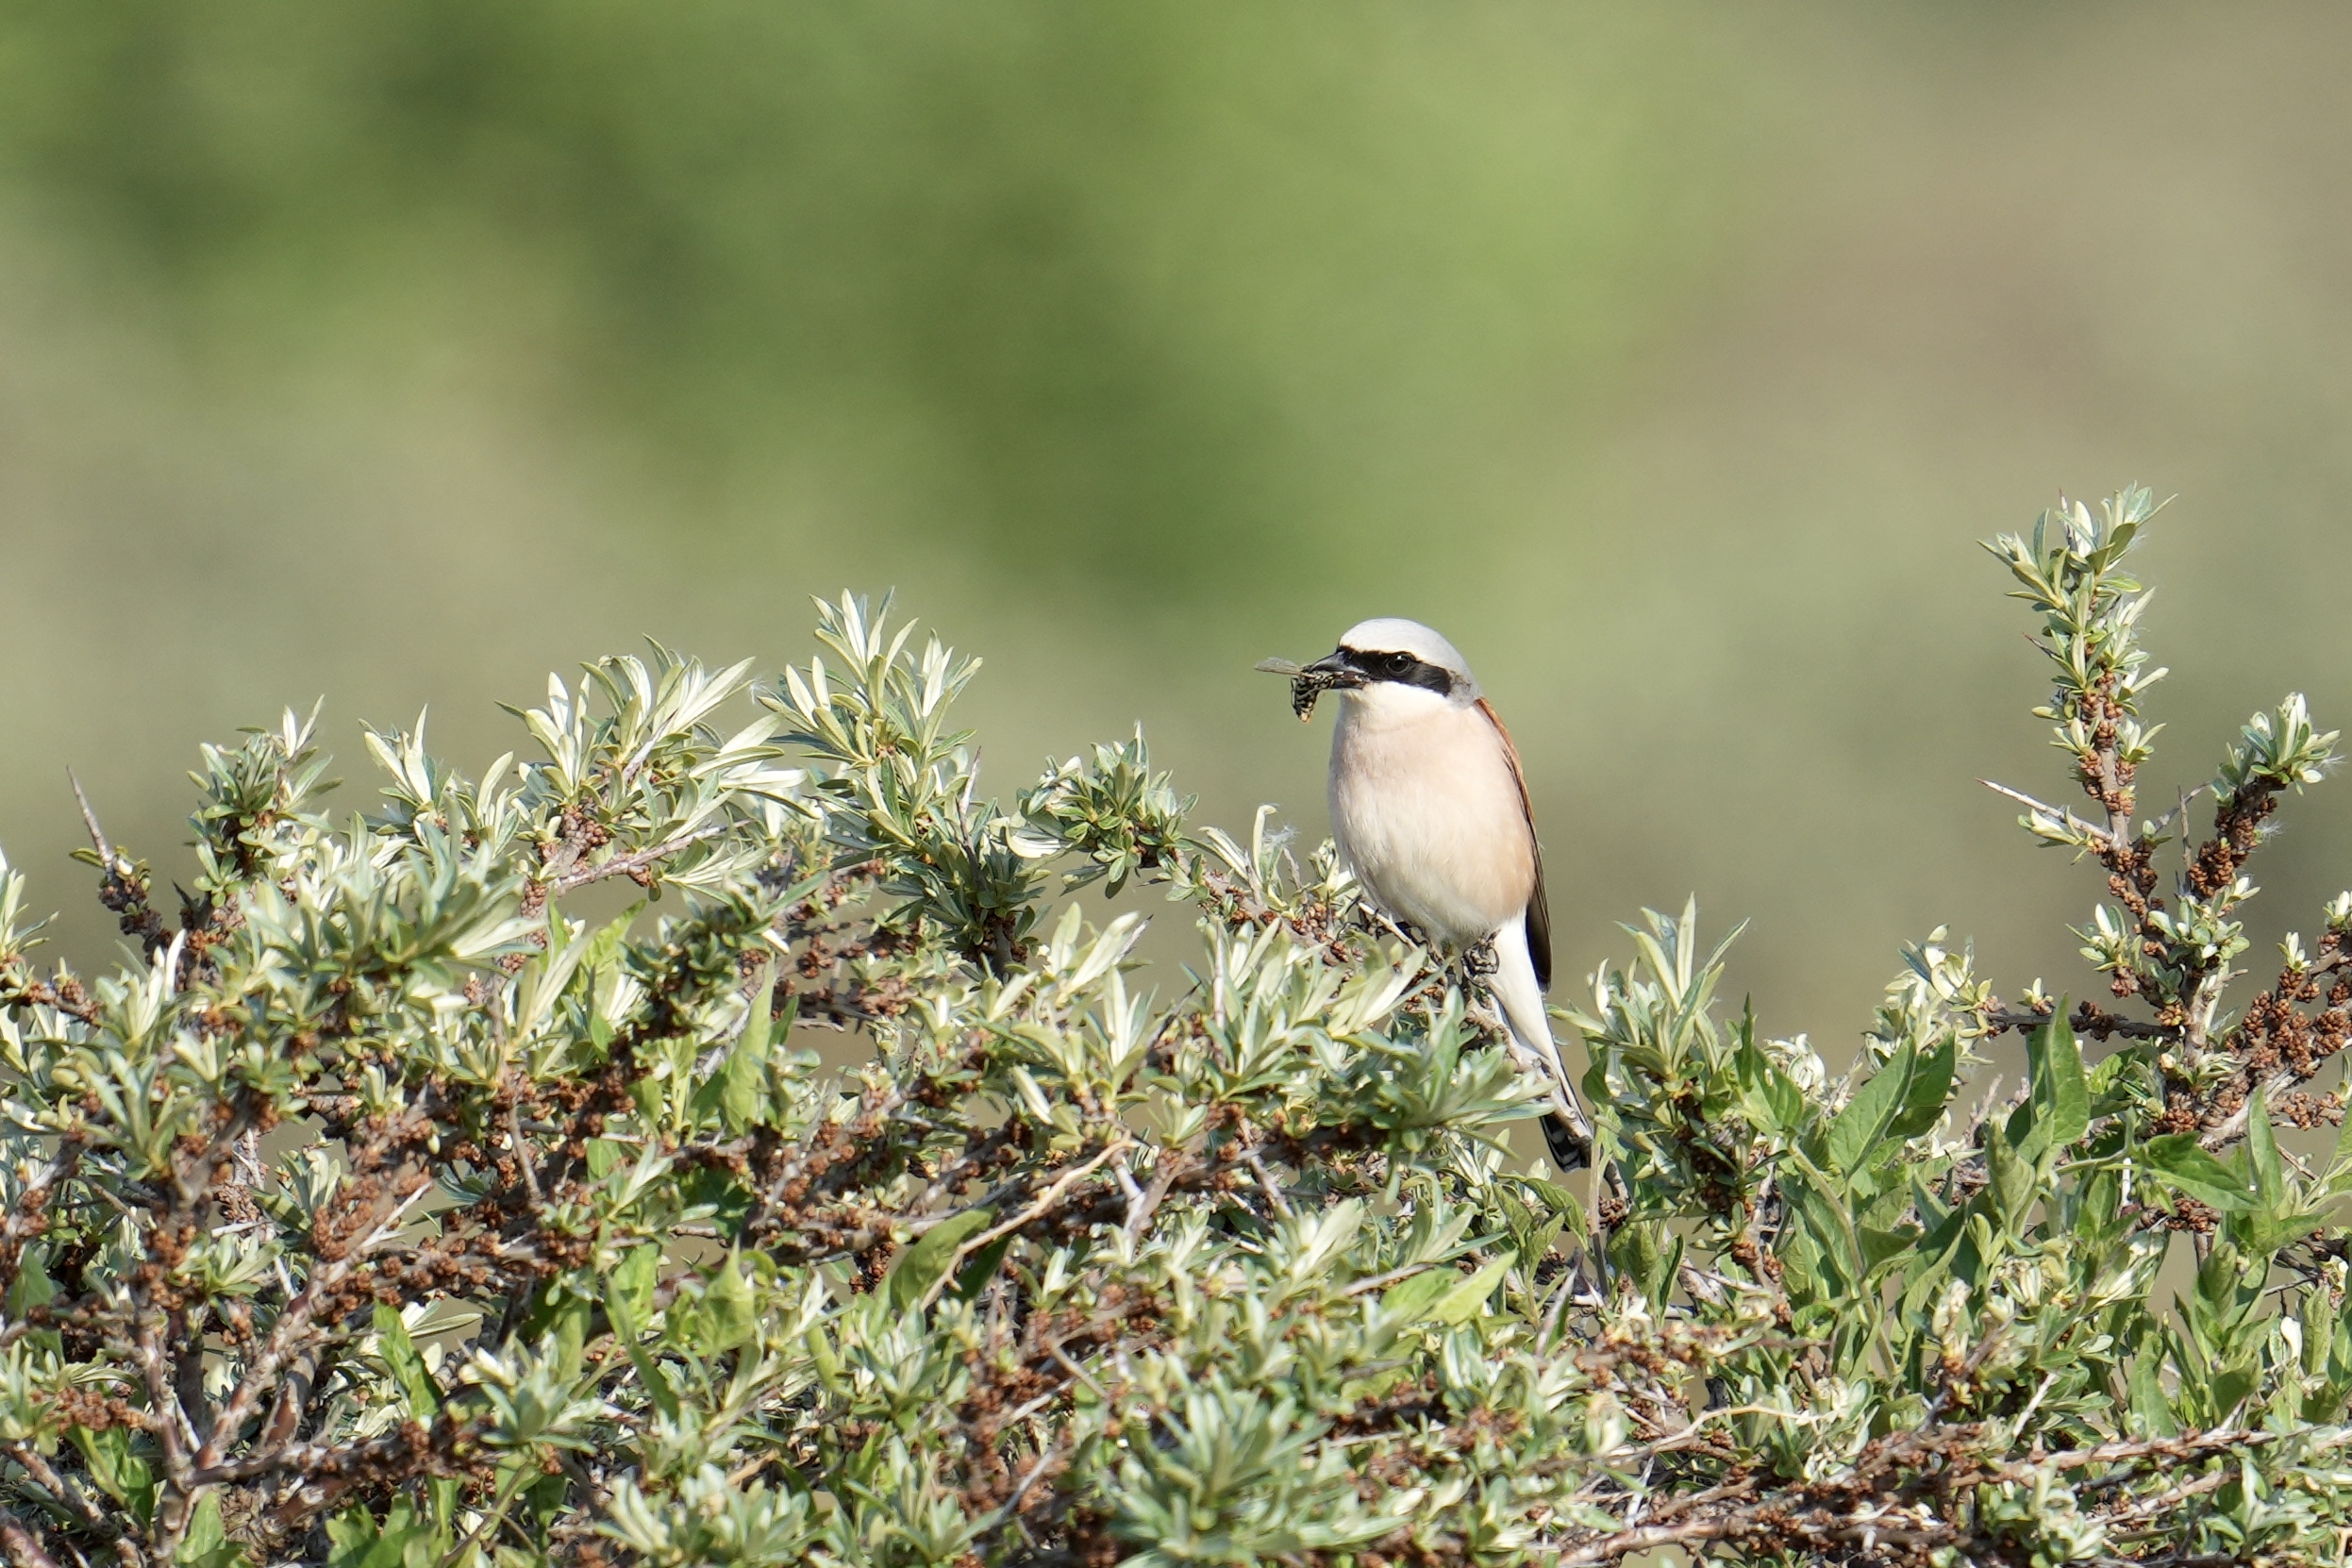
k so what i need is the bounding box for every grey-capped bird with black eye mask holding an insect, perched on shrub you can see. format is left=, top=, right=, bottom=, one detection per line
left=1259, top=618, right=1593, bottom=1171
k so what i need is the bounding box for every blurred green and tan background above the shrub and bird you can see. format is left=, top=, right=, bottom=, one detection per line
left=0, top=0, right=2352, bottom=1062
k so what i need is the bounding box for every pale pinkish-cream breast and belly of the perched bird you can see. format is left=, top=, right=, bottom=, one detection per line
left=1331, top=703, right=1536, bottom=947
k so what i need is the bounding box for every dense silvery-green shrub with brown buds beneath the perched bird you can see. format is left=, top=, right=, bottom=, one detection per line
left=0, top=492, right=2352, bottom=1568
